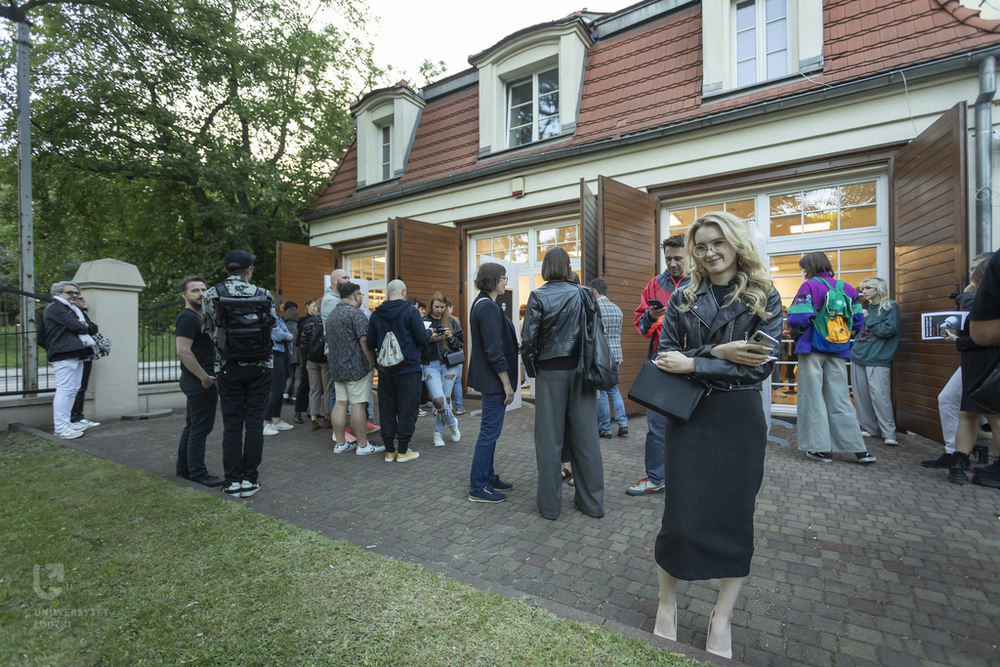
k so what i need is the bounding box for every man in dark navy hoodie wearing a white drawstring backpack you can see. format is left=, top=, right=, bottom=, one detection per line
left=366, top=280, right=431, bottom=463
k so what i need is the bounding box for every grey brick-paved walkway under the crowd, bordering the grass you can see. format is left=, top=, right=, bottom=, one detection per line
left=29, top=401, right=1000, bottom=667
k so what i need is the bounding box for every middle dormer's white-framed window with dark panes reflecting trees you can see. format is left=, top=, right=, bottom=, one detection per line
left=507, top=68, right=559, bottom=148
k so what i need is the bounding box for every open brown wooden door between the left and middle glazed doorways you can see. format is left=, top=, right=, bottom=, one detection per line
left=385, top=218, right=462, bottom=311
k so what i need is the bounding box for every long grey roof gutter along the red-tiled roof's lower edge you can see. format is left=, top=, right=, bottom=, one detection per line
left=300, top=47, right=1000, bottom=223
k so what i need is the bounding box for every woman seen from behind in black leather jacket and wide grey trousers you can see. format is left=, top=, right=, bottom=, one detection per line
left=521, top=246, right=604, bottom=519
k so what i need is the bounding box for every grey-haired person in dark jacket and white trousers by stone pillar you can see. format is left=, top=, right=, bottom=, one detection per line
left=43, top=282, right=97, bottom=440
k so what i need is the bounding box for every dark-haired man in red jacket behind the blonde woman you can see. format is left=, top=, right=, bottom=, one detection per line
left=625, top=234, right=687, bottom=496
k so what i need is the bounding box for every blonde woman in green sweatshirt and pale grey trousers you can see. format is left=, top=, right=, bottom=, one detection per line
left=851, top=277, right=900, bottom=447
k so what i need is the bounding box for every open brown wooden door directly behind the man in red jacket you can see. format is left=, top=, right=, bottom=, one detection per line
left=598, top=176, right=659, bottom=414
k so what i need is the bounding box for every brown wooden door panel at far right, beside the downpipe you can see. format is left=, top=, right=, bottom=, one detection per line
left=892, top=102, right=969, bottom=441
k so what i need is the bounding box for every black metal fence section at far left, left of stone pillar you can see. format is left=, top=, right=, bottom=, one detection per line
left=0, top=287, right=56, bottom=396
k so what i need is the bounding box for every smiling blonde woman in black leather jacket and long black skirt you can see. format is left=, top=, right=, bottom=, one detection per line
left=654, top=213, right=782, bottom=658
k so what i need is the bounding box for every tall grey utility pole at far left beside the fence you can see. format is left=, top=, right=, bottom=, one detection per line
left=15, top=19, right=38, bottom=396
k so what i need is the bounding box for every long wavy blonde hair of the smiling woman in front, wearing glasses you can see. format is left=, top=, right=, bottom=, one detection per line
left=677, top=212, right=773, bottom=318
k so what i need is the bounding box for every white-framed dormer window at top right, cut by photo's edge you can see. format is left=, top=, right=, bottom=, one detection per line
left=734, top=0, right=788, bottom=86
